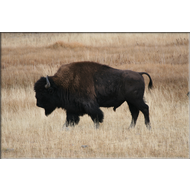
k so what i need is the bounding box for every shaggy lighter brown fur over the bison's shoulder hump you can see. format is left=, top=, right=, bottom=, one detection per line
left=52, top=62, right=100, bottom=99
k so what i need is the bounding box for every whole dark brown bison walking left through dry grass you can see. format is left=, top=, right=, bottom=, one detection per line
left=34, top=61, right=153, bottom=129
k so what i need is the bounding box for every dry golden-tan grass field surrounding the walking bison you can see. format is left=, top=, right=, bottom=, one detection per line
left=1, top=33, right=189, bottom=158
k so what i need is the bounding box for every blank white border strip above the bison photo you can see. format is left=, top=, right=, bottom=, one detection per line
left=0, top=0, right=190, bottom=32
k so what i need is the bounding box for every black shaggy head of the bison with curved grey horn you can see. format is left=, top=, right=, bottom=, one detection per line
left=34, top=76, right=59, bottom=116
